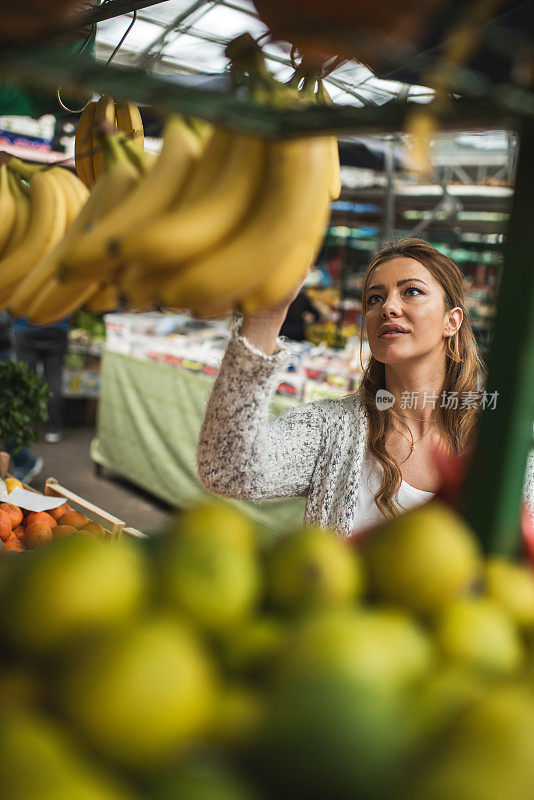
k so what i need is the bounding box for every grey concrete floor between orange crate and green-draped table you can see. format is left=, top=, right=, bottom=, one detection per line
left=28, top=423, right=173, bottom=533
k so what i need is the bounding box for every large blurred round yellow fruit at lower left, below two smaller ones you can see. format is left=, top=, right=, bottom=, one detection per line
left=58, top=615, right=216, bottom=768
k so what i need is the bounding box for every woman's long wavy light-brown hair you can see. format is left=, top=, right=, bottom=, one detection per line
left=358, top=239, right=486, bottom=517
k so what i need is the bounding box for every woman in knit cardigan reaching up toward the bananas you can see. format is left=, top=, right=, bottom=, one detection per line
left=197, top=239, right=534, bottom=535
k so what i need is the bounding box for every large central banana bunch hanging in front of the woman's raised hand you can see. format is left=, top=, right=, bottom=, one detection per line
left=59, top=37, right=340, bottom=317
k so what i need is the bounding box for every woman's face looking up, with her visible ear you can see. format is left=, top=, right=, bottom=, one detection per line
left=365, top=257, right=463, bottom=364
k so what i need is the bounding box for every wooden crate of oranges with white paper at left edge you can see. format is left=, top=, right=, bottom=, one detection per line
left=0, top=453, right=144, bottom=552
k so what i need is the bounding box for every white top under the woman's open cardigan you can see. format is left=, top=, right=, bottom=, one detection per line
left=353, top=448, right=434, bottom=533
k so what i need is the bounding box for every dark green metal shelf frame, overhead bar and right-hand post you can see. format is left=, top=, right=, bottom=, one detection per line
left=0, top=0, right=534, bottom=553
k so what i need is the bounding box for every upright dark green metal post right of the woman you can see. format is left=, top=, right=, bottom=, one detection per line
left=463, top=120, right=534, bottom=553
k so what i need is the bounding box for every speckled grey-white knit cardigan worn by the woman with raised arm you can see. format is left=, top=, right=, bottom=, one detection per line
left=197, top=331, right=534, bottom=535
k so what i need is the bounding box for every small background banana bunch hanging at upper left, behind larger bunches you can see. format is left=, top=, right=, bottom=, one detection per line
left=74, top=95, right=144, bottom=189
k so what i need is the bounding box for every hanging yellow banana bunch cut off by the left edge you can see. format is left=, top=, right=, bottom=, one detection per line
left=0, top=128, right=156, bottom=324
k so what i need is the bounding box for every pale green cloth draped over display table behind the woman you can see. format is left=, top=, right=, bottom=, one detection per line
left=91, top=350, right=304, bottom=529
